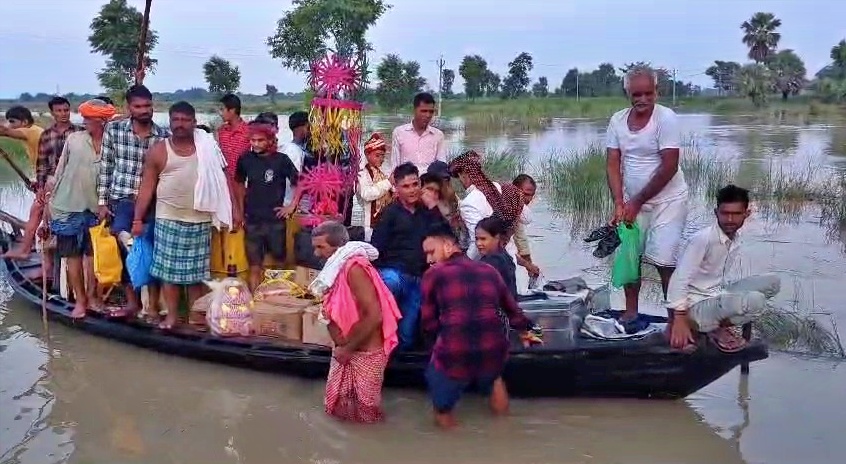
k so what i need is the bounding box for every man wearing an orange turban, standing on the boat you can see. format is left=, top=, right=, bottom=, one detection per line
left=46, top=99, right=116, bottom=319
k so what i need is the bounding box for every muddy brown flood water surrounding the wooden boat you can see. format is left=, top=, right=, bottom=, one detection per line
left=0, top=115, right=846, bottom=464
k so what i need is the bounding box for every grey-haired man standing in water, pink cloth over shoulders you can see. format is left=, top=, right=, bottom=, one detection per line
left=309, top=221, right=401, bottom=423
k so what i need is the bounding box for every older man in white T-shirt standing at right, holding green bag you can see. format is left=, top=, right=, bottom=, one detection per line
left=606, top=67, right=688, bottom=333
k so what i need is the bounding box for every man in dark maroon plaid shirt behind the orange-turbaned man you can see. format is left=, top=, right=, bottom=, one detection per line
left=5, top=97, right=83, bottom=260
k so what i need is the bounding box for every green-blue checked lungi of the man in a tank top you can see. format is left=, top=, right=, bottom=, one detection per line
left=150, top=219, right=211, bottom=285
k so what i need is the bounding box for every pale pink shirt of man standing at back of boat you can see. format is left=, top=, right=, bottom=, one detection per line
left=391, top=123, right=448, bottom=169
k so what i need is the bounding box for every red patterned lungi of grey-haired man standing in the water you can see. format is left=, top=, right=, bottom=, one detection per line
left=324, top=349, right=388, bottom=423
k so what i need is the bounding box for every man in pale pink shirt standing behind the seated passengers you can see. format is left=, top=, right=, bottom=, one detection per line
left=391, top=92, right=447, bottom=172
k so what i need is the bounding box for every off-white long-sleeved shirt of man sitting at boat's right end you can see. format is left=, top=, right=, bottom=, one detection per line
left=667, top=223, right=741, bottom=309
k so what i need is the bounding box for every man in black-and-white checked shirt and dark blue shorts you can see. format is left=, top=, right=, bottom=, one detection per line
left=97, top=85, right=170, bottom=318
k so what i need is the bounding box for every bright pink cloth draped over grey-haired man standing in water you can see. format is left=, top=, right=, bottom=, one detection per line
left=323, top=255, right=402, bottom=356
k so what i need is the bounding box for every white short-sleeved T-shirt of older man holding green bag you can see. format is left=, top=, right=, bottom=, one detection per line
left=606, top=105, right=687, bottom=204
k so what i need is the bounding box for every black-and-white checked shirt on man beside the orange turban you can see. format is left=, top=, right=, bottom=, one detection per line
left=97, top=119, right=170, bottom=206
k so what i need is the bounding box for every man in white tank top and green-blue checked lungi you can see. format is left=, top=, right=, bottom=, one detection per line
left=132, top=101, right=217, bottom=330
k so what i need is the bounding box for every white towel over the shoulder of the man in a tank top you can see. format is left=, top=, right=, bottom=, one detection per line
left=194, top=129, right=232, bottom=229
